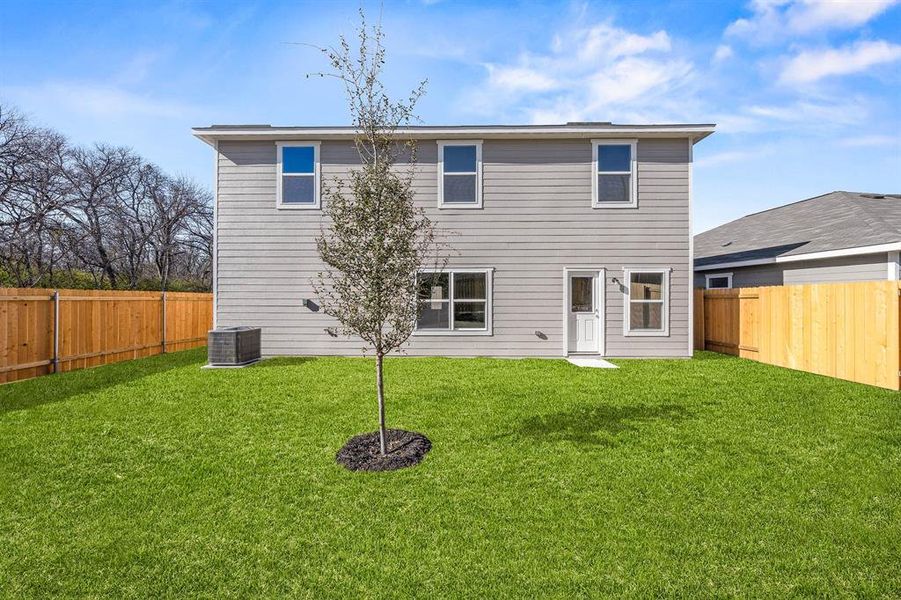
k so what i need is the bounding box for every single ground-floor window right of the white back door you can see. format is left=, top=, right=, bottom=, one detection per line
left=623, top=269, right=670, bottom=336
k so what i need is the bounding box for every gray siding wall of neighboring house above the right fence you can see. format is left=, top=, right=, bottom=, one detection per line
left=695, top=252, right=888, bottom=287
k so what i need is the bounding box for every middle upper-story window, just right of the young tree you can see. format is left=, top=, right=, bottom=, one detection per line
left=438, top=141, right=482, bottom=208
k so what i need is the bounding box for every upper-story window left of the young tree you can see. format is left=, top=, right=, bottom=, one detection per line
left=276, top=142, right=320, bottom=208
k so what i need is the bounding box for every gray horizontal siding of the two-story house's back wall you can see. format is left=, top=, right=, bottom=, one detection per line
left=217, top=139, right=689, bottom=356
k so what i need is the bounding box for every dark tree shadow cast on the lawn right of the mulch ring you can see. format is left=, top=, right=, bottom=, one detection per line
left=513, top=404, right=692, bottom=446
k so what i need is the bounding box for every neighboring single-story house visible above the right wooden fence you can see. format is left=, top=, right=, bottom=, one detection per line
left=694, top=192, right=901, bottom=288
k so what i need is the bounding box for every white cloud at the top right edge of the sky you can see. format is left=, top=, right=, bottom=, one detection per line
left=726, top=0, right=899, bottom=43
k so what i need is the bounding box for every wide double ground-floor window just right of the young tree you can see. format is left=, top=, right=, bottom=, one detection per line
left=416, top=269, right=491, bottom=334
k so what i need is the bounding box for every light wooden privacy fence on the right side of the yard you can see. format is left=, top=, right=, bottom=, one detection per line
left=694, top=281, right=901, bottom=390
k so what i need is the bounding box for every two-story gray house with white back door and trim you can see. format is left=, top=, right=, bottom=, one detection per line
left=194, top=123, right=713, bottom=357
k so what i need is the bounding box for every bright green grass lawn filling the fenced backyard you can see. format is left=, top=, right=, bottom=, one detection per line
left=0, top=350, right=901, bottom=598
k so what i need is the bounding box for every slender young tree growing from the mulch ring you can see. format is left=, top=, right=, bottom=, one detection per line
left=314, top=10, right=439, bottom=456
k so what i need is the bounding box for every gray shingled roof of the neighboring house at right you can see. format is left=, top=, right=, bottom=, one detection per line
left=694, top=192, right=901, bottom=270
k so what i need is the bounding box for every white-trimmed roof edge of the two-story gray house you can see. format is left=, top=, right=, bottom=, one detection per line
left=192, top=121, right=716, bottom=144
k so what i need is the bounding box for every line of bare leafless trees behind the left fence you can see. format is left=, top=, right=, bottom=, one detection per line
left=0, top=105, right=213, bottom=290
